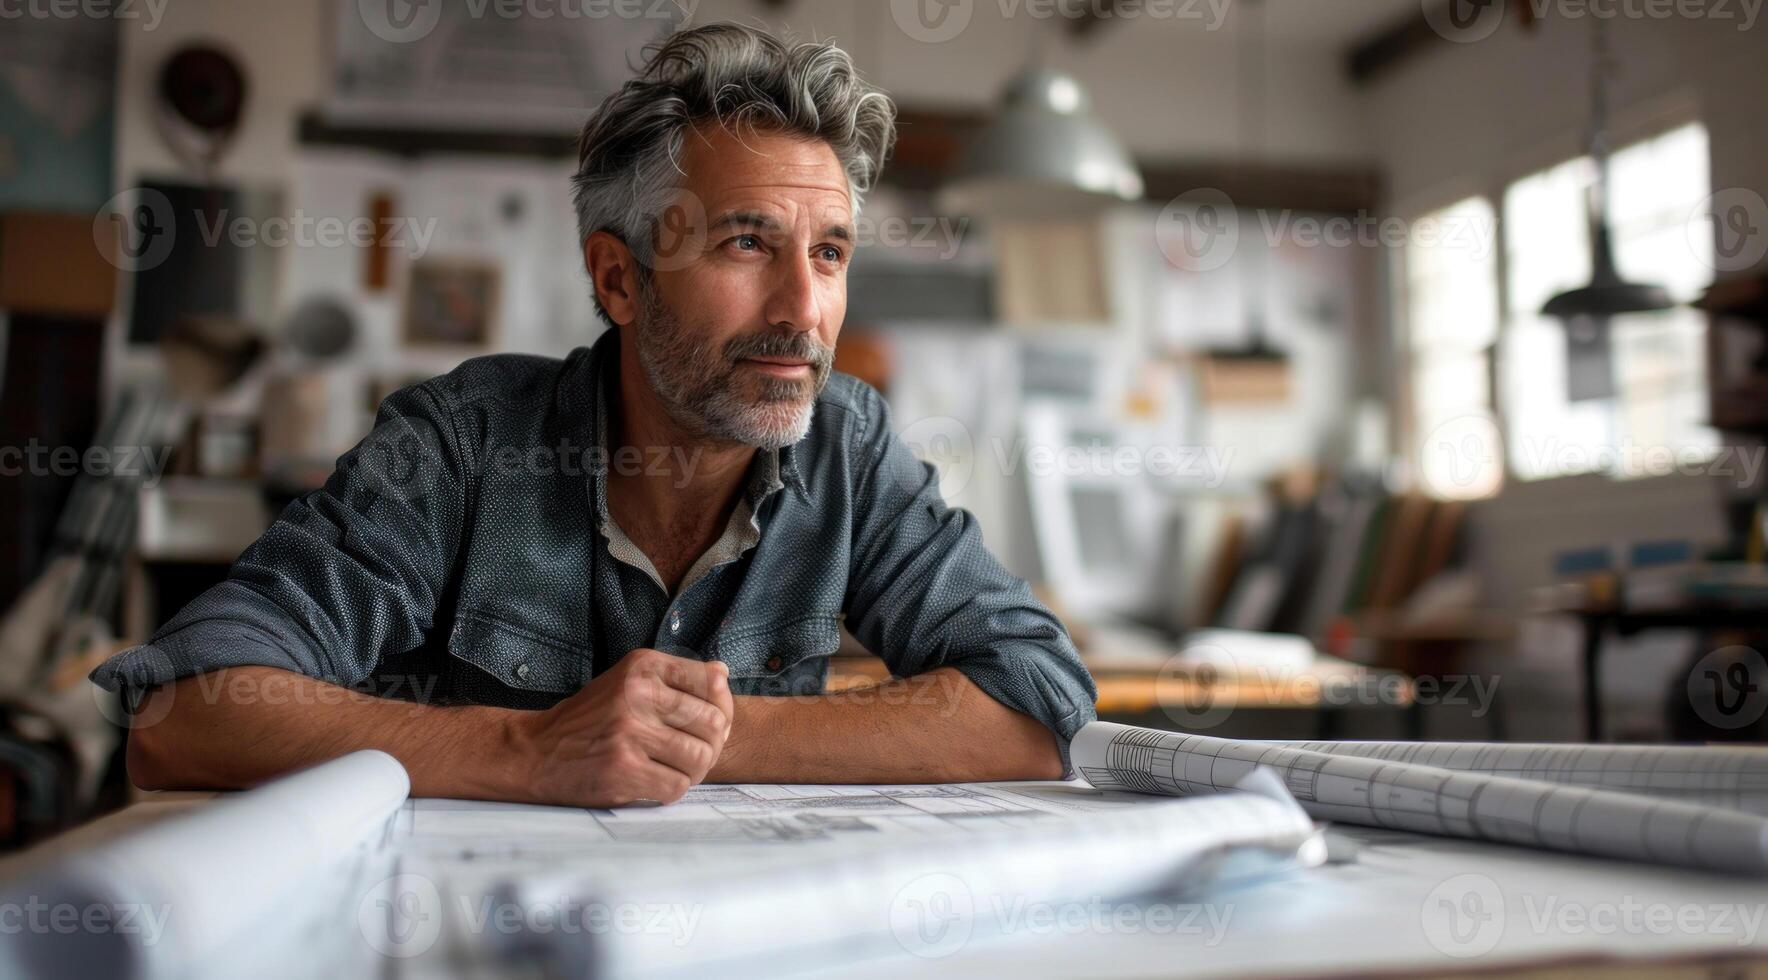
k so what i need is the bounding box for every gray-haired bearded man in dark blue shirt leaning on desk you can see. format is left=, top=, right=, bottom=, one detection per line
left=94, top=25, right=1094, bottom=807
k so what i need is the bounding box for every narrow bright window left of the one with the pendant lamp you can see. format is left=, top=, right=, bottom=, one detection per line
left=1406, top=198, right=1503, bottom=499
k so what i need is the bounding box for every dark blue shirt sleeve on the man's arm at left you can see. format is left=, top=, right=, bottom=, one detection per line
left=92, top=386, right=467, bottom=701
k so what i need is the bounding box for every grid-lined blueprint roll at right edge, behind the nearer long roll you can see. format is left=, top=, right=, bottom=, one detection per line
left=1284, top=741, right=1768, bottom=817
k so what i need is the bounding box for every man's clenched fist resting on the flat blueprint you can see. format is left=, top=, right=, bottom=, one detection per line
left=516, top=647, right=735, bottom=807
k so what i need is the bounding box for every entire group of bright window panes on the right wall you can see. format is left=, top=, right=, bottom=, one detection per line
left=1404, top=124, right=1718, bottom=497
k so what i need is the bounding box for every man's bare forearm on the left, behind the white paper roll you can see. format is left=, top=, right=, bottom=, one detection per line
left=129, top=667, right=534, bottom=800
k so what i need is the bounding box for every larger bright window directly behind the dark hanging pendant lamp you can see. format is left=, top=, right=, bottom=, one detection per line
left=1497, top=124, right=1718, bottom=479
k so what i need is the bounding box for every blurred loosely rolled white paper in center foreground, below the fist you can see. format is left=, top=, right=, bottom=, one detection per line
left=477, top=773, right=1326, bottom=976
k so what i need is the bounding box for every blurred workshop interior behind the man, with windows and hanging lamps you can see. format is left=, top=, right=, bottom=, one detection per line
left=0, top=0, right=1768, bottom=846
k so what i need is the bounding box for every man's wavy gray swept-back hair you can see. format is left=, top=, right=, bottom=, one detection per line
left=571, top=23, right=896, bottom=325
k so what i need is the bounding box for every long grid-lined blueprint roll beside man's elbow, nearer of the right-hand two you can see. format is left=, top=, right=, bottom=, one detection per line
left=1071, top=722, right=1768, bottom=876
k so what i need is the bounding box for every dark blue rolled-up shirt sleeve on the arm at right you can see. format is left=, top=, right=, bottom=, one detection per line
left=847, top=389, right=1096, bottom=769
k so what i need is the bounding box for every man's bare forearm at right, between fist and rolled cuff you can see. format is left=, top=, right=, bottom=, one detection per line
left=707, top=667, right=1063, bottom=784
